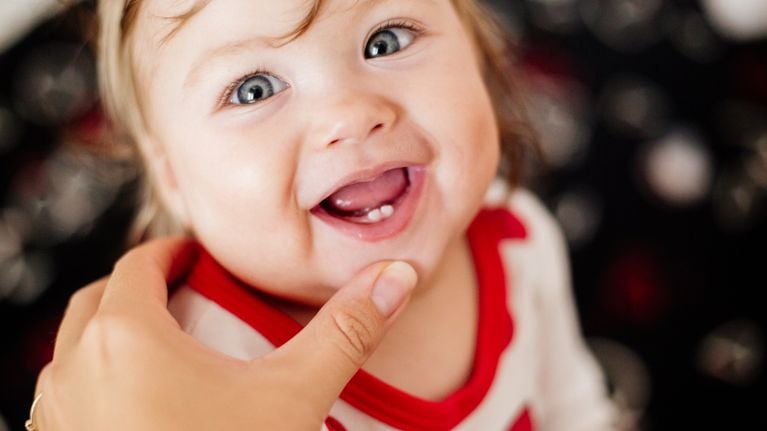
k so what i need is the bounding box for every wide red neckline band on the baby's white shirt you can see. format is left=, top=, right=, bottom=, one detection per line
left=187, top=209, right=527, bottom=430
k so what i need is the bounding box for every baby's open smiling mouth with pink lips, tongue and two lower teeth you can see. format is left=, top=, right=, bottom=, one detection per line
left=311, top=167, right=424, bottom=241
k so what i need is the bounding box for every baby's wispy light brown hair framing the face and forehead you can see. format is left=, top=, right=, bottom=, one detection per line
left=98, top=0, right=538, bottom=243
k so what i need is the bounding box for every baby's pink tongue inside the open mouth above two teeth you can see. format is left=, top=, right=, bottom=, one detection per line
left=324, top=168, right=407, bottom=213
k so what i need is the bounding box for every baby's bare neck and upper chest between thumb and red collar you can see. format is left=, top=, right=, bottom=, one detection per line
left=281, top=236, right=478, bottom=401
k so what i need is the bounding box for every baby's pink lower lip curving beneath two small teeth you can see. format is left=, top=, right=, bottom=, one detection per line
left=312, top=167, right=426, bottom=242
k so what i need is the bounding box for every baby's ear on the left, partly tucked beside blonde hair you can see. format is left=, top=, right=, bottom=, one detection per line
left=141, top=138, right=190, bottom=230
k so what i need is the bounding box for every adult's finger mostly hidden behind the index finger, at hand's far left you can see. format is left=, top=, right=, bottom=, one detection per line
left=53, top=277, right=107, bottom=360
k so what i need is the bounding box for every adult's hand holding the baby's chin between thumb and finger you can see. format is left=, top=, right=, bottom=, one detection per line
left=33, top=239, right=416, bottom=431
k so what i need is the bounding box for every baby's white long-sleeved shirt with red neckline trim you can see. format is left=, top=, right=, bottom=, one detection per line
left=169, top=190, right=612, bottom=431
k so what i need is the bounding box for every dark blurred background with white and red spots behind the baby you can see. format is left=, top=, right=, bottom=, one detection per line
left=0, top=0, right=767, bottom=431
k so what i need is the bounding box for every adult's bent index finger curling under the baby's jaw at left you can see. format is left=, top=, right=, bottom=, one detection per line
left=99, top=237, right=197, bottom=311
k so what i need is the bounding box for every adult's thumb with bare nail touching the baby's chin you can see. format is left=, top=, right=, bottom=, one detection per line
left=274, top=262, right=417, bottom=409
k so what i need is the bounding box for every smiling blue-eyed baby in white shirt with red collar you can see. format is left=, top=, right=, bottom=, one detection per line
left=100, top=0, right=610, bottom=431
